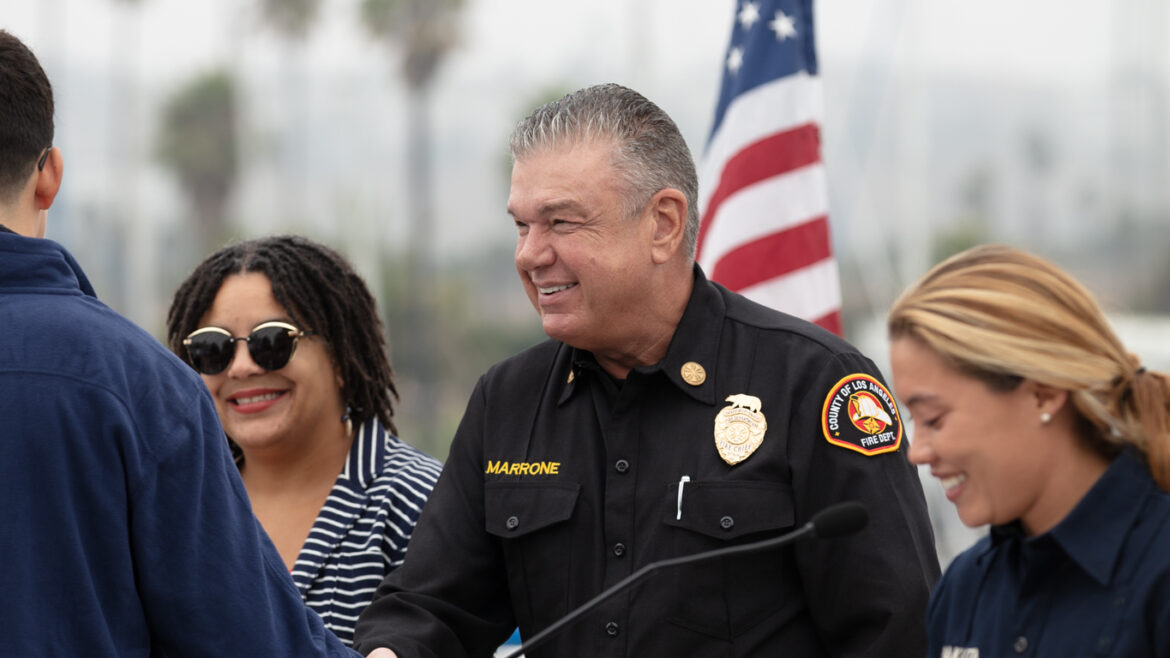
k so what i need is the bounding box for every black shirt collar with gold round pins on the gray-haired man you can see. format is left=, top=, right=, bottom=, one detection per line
left=558, top=263, right=727, bottom=404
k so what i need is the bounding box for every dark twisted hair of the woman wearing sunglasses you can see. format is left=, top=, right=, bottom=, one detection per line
left=166, top=235, right=398, bottom=433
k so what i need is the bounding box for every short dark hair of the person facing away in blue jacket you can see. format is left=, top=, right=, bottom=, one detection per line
left=0, top=29, right=53, bottom=201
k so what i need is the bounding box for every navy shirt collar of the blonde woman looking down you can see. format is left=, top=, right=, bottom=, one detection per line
left=991, top=450, right=1155, bottom=585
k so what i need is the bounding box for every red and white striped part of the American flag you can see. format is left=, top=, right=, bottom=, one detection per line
left=698, top=73, right=841, bottom=334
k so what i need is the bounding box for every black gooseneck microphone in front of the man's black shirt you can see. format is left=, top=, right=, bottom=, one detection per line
left=504, top=500, right=869, bottom=658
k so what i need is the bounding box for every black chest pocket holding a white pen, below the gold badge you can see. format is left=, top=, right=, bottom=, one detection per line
left=663, top=480, right=803, bottom=640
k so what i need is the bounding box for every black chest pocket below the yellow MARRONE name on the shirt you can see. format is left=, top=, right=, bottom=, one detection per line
left=483, top=482, right=589, bottom=628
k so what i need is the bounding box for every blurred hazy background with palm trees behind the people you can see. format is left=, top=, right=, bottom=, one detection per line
left=0, top=0, right=1170, bottom=560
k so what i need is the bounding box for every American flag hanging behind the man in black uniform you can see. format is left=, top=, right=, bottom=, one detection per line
left=698, top=0, right=841, bottom=334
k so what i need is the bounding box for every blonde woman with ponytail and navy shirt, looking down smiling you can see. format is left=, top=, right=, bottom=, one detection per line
left=889, top=246, right=1170, bottom=658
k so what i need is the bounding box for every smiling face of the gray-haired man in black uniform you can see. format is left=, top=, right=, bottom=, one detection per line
left=508, top=136, right=656, bottom=354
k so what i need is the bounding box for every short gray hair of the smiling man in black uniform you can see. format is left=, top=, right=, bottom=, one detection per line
left=510, top=83, right=698, bottom=259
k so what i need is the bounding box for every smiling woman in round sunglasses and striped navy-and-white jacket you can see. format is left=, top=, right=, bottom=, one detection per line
left=167, top=235, right=440, bottom=643
